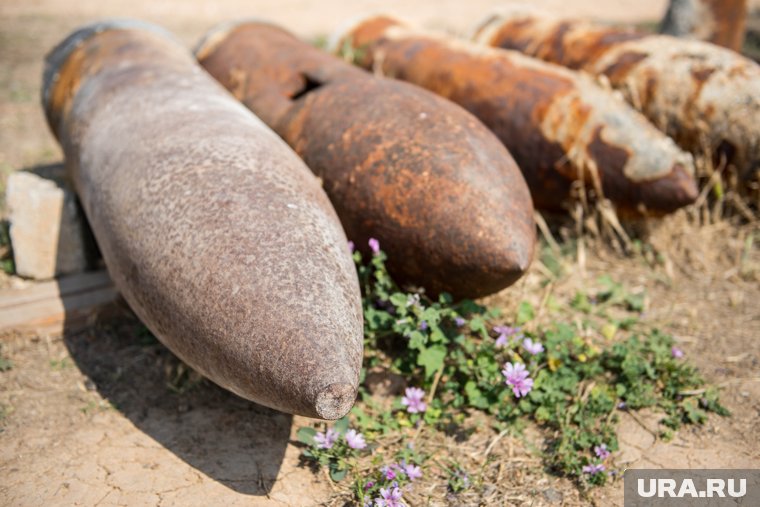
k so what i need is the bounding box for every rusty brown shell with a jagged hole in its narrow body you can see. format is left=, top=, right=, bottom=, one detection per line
left=197, top=22, right=535, bottom=297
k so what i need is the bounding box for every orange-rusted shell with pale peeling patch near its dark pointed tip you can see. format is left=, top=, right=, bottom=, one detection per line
left=338, top=17, right=697, bottom=213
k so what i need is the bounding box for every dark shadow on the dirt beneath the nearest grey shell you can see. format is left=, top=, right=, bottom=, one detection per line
left=65, top=314, right=292, bottom=495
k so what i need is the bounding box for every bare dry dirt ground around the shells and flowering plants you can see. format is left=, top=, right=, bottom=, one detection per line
left=0, top=0, right=760, bottom=506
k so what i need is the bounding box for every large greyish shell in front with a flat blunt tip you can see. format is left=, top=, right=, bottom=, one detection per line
left=43, top=22, right=362, bottom=419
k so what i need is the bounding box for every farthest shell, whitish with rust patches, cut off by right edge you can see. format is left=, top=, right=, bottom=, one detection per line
left=475, top=10, right=760, bottom=180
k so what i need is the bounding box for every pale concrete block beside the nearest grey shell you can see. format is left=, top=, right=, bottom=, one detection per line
left=6, top=166, right=92, bottom=280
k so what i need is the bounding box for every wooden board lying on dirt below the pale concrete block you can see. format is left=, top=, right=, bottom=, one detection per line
left=0, top=271, right=119, bottom=334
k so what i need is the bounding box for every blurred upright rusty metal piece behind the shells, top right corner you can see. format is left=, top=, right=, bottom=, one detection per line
left=660, top=0, right=747, bottom=51
